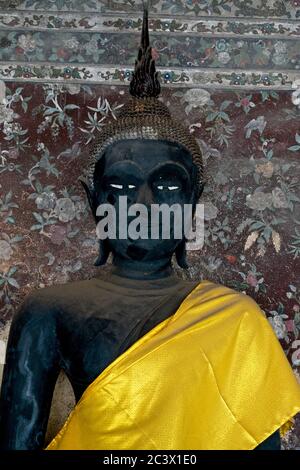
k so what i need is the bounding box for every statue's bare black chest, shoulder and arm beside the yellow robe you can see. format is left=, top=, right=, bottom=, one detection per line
left=0, top=268, right=199, bottom=449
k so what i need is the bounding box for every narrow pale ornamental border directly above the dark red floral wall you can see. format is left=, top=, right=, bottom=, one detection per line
left=0, top=62, right=300, bottom=90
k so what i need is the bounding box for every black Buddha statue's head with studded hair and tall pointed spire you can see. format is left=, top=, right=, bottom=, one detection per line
left=80, top=1, right=203, bottom=275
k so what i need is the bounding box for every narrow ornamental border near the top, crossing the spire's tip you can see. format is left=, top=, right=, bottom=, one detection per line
left=0, top=11, right=300, bottom=39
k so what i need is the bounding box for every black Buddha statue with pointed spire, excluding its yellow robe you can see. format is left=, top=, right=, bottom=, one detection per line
left=0, top=3, right=296, bottom=450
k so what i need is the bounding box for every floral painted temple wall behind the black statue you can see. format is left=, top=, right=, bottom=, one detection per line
left=0, top=0, right=300, bottom=449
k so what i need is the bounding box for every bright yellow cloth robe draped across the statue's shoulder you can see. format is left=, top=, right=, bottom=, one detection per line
left=47, top=281, right=300, bottom=450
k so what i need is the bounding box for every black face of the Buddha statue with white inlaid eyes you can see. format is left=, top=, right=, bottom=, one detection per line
left=85, top=139, right=196, bottom=270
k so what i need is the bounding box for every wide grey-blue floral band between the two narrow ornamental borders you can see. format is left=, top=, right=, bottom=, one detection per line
left=0, top=31, right=300, bottom=70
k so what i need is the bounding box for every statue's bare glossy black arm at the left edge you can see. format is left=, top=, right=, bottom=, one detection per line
left=0, top=293, right=59, bottom=450
